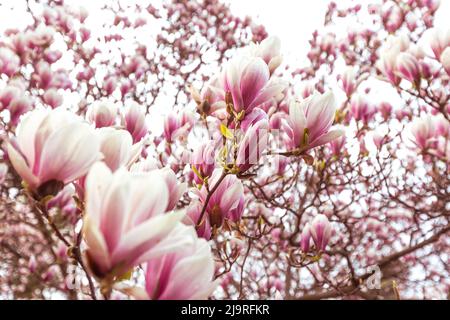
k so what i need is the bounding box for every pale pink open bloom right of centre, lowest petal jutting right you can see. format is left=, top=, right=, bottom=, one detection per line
left=287, top=92, right=343, bottom=151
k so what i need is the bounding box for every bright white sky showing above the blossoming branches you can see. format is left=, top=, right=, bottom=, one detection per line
left=0, top=0, right=450, bottom=61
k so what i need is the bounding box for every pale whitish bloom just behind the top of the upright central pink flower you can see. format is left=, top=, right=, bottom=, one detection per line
left=243, top=37, right=283, bottom=73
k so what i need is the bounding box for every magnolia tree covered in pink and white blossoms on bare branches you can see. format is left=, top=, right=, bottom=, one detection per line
left=0, top=0, right=450, bottom=299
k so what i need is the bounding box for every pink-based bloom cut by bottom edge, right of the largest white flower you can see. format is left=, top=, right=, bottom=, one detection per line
left=145, top=225, right=217, bottom=300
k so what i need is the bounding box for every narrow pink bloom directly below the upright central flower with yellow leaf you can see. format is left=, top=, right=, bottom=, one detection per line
left=236, top=115, right=269, bottom=173
